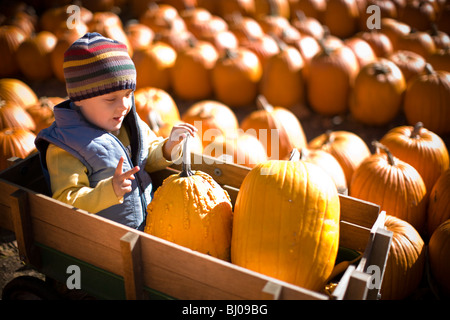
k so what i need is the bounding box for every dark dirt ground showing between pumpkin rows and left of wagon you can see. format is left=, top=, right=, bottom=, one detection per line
left=0, top=79, right=450, bottom=299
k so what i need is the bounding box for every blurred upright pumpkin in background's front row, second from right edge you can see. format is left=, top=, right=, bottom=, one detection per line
left=349, top=58, right=406, bottom=125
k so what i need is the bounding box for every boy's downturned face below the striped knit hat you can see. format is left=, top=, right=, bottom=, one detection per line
left=76, top=89, right=133, bottom=132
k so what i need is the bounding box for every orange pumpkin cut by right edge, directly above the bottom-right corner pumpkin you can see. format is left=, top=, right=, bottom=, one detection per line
left=427, top=168, right=450, bottom=236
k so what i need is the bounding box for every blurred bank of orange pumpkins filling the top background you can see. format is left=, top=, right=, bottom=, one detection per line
left=0, top=0, right=450, bottom=134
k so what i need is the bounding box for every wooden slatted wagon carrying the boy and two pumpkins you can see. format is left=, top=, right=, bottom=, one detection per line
left=0, top=154, right=392, bottom=300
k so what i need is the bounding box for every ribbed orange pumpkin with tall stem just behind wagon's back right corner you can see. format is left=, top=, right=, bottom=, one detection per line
left=349, top=142, right=428, bottom=233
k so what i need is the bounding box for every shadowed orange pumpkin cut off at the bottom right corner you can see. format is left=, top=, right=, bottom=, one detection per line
left=428, top=219, right=450, bottom=298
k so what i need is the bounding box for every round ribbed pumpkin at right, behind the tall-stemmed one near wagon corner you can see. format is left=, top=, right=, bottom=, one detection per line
left=380, top=122, right=449, bottom=193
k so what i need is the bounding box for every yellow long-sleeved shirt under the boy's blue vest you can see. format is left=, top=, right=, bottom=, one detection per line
left=46, top=127, right=181, bottom=213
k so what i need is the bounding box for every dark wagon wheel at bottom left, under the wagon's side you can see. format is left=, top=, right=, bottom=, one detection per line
left=2, top=276, right=61, bottom=300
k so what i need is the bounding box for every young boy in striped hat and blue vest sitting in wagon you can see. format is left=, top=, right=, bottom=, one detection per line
left=35, top=33, right=196, bottom=230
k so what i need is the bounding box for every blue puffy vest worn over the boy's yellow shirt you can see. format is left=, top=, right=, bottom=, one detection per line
left=35, top=99, right=152, bottom=230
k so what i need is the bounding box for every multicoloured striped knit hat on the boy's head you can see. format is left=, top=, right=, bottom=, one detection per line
left=63, top=33, right=136, bottom=101
